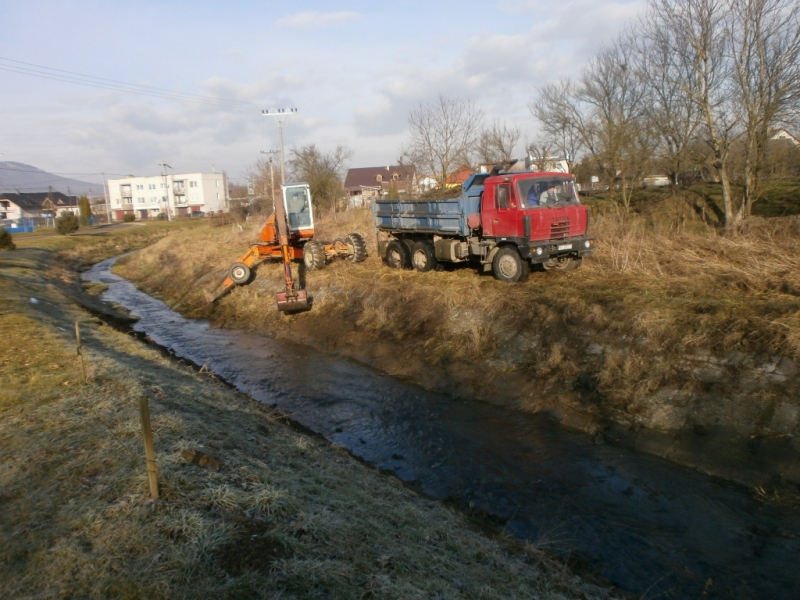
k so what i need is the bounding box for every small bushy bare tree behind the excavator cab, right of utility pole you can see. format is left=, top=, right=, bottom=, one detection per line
left=289, top=144, right=353, bottom=210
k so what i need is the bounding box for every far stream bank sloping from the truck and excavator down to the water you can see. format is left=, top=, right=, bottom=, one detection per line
left=118, top=210, right=800, bottom=486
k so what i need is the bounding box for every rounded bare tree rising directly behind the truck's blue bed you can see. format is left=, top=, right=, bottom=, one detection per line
left=402, top=95, right=483, bottom=187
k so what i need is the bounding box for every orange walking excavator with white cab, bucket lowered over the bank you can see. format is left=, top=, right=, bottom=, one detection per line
left=207, top=183, right=367, bottom=312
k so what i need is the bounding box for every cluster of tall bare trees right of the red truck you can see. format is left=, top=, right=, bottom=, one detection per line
left=530, top=0, right=800, bottom=227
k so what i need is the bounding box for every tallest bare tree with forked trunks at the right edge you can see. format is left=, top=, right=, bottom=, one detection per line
left=642, top=0, right=800, bottom=228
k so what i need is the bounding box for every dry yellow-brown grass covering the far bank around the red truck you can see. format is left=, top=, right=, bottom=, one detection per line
left=114, top=198, right=800, bottom=440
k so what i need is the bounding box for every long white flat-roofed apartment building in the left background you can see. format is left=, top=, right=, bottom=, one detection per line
left=108, top=173, right=229, bottom=221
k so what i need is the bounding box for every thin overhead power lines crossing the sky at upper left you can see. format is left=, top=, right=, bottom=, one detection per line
left=0, top=56, right=257, bottom=110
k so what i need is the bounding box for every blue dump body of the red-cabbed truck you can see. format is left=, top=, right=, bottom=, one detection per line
left=372, top=173, right=489, bottom=237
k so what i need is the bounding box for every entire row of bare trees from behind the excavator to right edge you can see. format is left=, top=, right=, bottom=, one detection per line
left=241, top=0, right=800, bottom=227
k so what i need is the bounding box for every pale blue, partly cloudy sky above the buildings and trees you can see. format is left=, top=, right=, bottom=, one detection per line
left=0, top=0, right=645, bottom=188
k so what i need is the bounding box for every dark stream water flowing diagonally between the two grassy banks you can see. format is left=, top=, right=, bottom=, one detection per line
left=84, top=260, right=800, bottom=598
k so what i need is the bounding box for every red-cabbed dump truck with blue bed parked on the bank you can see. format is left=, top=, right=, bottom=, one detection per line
left=372, top=165, right=594, bottom=282
